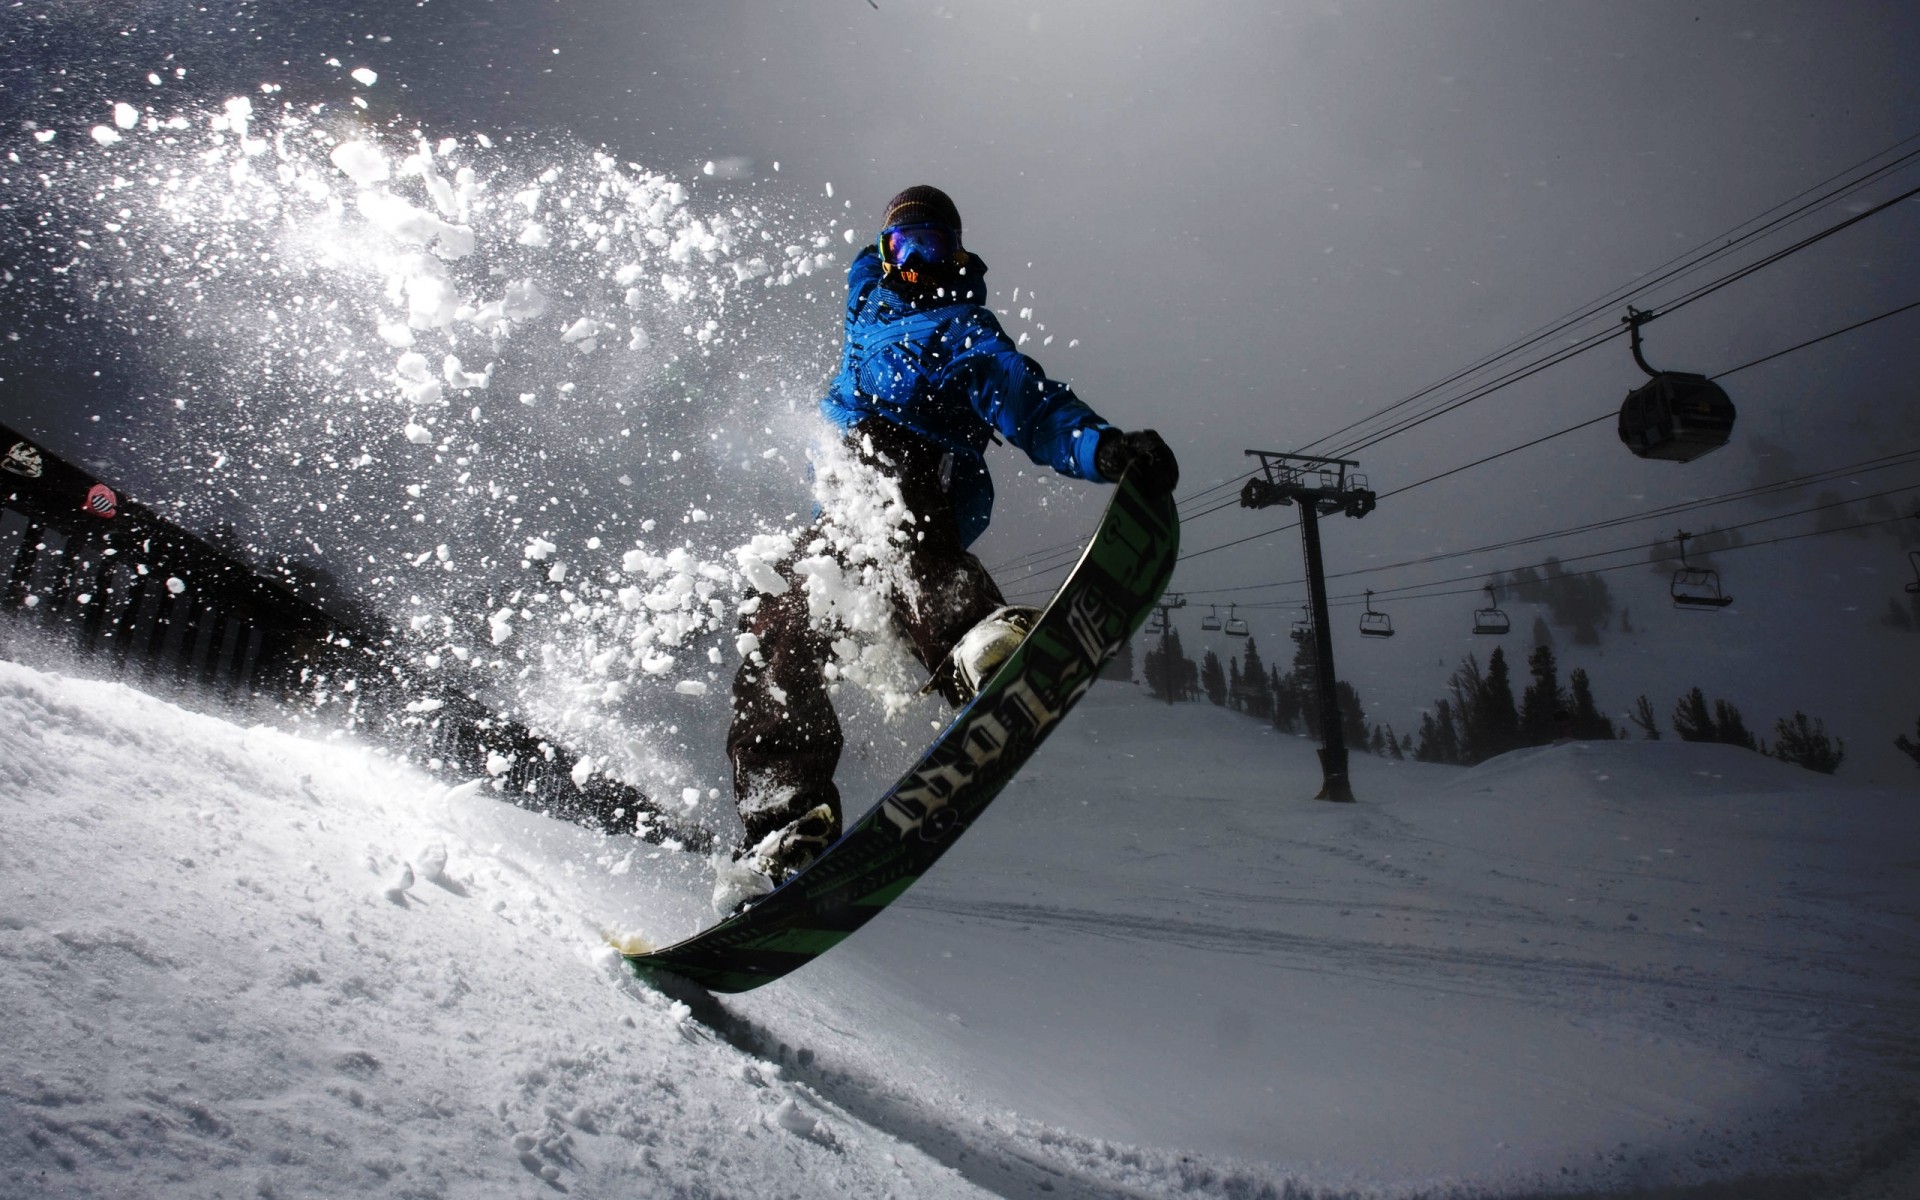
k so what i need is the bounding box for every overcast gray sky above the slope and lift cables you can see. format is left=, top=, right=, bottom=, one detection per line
left=0, top=0, right=1920, bottom=768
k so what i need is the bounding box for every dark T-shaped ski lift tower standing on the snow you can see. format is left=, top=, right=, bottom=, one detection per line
left=1240, top=449, right=1375, bottom=803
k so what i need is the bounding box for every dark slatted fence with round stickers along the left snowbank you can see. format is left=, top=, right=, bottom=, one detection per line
left=0, top=424, right=712, bottom=849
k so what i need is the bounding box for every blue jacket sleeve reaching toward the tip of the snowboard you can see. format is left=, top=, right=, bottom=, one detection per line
left=952, top=309, right=1112, bottom=482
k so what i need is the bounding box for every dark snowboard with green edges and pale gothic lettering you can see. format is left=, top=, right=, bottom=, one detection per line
left=624, top=472, right=1179, bottom=993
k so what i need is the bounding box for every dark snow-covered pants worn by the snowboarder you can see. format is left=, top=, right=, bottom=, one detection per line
left=726, top=417, right=1006, bottom=847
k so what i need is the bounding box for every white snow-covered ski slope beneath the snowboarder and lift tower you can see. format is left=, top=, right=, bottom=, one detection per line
left=0, top=662, right=1920, bottom=1196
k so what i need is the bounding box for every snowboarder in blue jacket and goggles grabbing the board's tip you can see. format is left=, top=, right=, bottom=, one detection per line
left=714, top=184, right=1179, bottom=912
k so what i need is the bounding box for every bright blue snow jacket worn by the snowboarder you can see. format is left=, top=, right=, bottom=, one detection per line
left=820, top=246, right=1112, bottom=545
